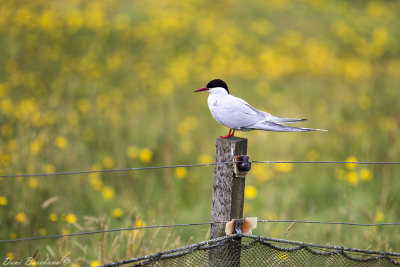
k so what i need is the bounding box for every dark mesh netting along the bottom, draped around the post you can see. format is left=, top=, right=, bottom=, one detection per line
left=106, top=235, right=400, bottom=267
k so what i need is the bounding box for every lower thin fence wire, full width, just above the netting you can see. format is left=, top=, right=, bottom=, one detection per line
left=0, top=220, right=400, bottom=243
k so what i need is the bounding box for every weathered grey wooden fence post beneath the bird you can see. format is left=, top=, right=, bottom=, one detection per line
left=209, top=137, right=247, bottom=266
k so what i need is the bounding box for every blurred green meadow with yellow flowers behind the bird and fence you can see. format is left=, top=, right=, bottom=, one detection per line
left=0, top=0, right=400, bottom=267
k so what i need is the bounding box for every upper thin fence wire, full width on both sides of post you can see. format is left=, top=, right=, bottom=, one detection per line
left=0, top=160, right=400, bottom=178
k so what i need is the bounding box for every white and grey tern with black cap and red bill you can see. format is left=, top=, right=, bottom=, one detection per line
left=194, top=79, right=326, bottom=138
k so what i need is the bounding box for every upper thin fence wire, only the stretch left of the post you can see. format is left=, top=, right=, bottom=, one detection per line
left=0, top=161, right=233, bottom=178
